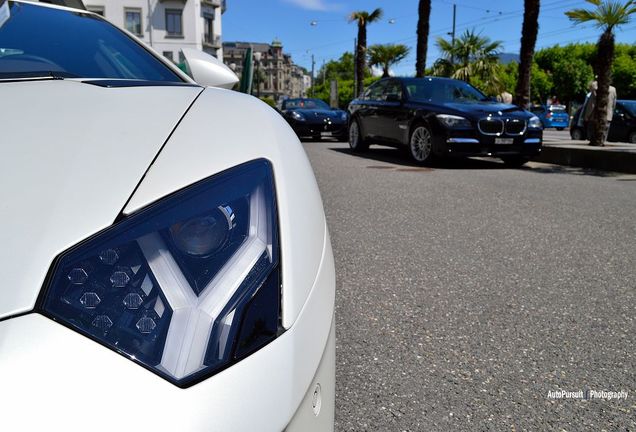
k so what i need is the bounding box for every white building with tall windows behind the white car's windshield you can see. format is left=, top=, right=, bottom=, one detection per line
left=84, top=0, right=226, bottom=63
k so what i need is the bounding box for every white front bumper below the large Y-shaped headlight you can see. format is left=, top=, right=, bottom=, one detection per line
left=0, top=234, right=335, bottom=432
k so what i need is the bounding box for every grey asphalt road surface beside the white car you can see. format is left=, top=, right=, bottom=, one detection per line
left=303, top=142, right=636, bottom=431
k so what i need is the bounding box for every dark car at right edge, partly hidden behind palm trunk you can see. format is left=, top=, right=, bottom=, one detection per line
left=570, top=100, right=636, bottom=144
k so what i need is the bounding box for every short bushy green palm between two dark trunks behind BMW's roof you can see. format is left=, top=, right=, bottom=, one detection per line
left=433, top=30, right=501, bottom=87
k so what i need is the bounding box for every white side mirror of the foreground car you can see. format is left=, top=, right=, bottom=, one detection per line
left=181, top=48, right=239, bottom=89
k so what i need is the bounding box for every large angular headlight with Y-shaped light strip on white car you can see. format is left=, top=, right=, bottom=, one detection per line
left=40, top=160, right=280, bottom=387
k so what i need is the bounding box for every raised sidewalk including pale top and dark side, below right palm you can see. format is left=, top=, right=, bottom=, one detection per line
left=533, top=137, right=636, bottom=174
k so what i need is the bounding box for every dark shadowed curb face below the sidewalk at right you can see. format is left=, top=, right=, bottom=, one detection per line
left=532, top=144, right=636, bottom=174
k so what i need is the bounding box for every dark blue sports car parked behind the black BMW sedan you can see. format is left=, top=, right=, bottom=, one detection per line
left=281, top=98, right=349, bottom=141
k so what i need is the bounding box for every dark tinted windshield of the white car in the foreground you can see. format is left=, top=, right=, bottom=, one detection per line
left=0, top=1, right=183, bottom=83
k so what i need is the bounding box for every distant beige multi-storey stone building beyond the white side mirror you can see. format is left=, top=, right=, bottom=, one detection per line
left=223, top=40, right=311, bottom=101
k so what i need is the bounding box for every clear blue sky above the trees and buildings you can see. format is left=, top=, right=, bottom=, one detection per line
left=223, top=0, right=636, bottom=75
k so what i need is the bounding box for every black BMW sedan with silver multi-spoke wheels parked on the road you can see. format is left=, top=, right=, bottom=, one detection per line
left=349, top=77, right=543, bottom=166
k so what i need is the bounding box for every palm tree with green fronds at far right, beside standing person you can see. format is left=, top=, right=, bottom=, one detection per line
left=565, top=0, right=636, bottom=146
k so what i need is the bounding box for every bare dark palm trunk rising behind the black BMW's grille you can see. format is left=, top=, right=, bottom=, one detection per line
left=515, top=0, right=540, bottom=108
